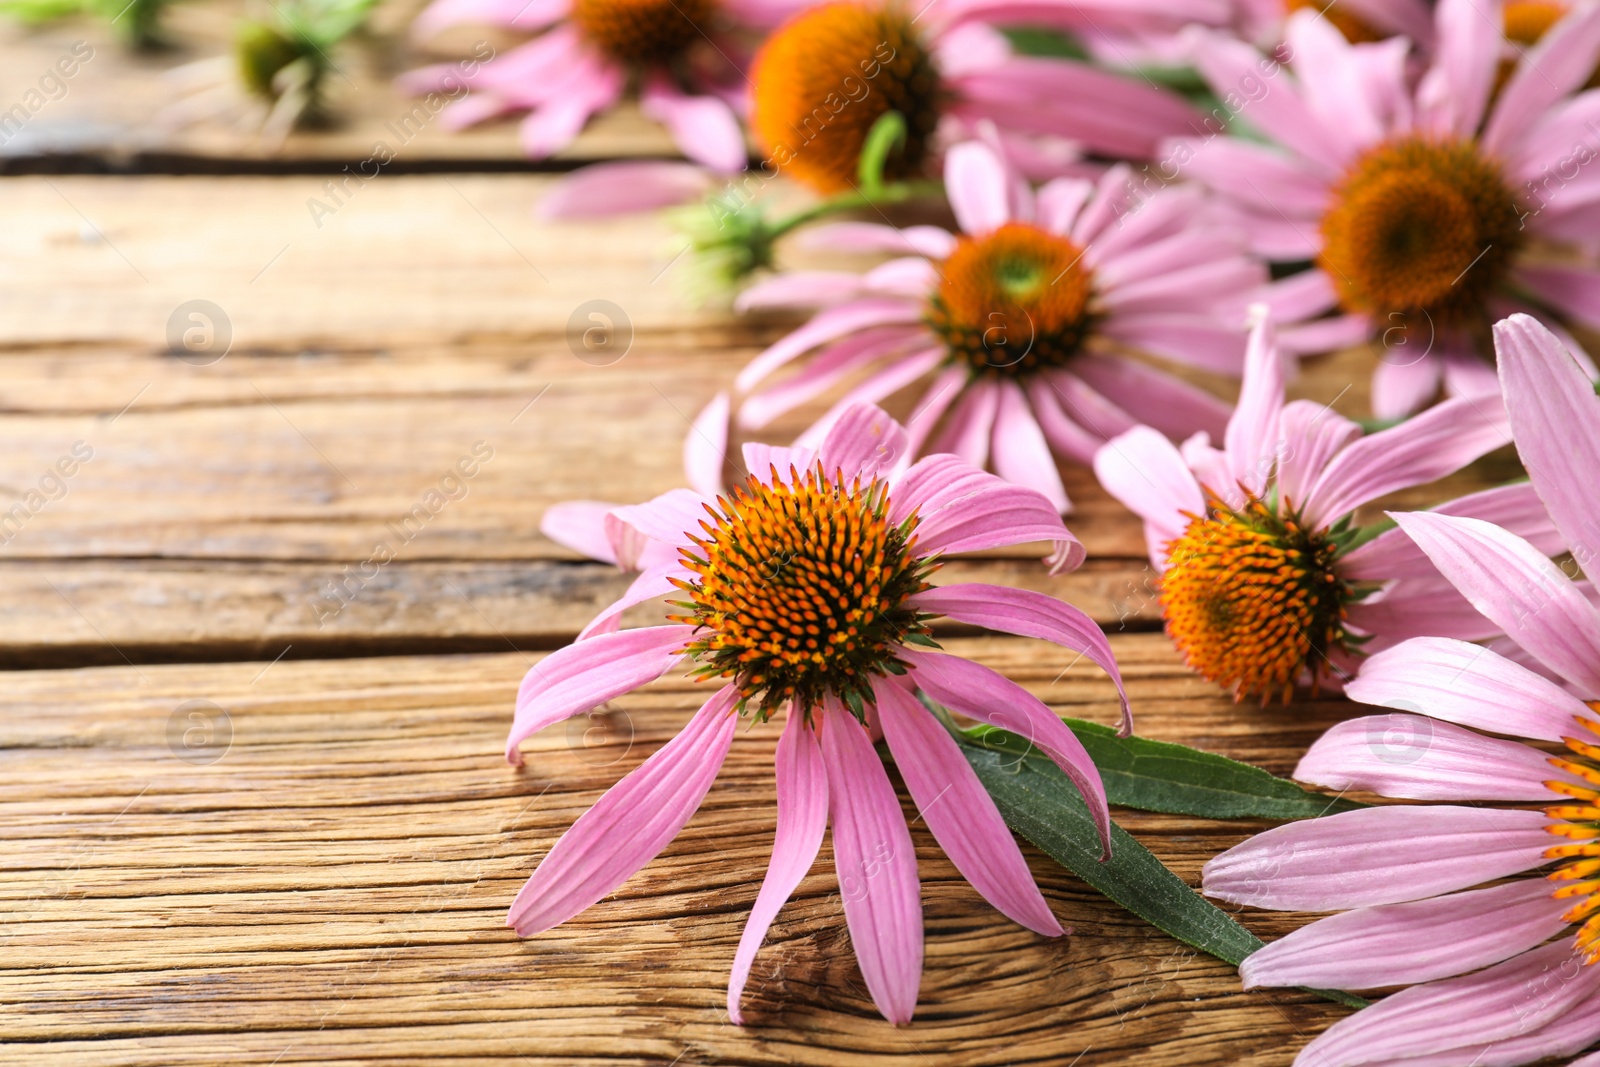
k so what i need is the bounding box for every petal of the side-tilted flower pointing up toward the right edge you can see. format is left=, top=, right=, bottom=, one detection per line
left=1302, top=398, right=1510, bottom=526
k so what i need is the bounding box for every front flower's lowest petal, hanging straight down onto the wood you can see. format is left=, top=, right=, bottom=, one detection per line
left=822, top=697, right=922, bottom=1025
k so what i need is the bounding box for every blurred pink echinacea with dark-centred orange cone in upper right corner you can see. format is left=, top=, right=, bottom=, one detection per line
left=1168, top=0, right=1600, bottom=419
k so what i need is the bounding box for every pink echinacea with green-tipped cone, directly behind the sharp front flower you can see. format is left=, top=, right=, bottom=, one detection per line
left=738, top=142, right=1266, bottom=510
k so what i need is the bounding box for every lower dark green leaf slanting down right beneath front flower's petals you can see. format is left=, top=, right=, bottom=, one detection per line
left=957, top=733, right=1366, bottom=1008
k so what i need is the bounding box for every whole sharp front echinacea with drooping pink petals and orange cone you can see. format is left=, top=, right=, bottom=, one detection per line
left=506, top=405, right=1126, bottom=1024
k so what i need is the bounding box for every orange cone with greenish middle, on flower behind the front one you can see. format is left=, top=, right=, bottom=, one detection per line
left=928, top=222, right=1094, bottom=378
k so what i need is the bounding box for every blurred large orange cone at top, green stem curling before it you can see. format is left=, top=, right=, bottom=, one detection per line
left=750, top=0, right=944, bottom=194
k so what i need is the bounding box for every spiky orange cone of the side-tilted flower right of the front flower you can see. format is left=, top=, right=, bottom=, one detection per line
left=1160, top=494, right=1355, bottom=702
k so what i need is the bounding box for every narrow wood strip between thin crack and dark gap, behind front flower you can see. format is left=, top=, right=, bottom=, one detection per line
left=0, top=560, right=1160, bottom=667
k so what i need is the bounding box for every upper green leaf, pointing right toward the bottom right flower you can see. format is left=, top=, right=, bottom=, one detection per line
left=963, top=718, right=1366, bottom=819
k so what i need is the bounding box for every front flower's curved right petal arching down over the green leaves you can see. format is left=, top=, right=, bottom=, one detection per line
left=901, top=649, right=1110, bottom=859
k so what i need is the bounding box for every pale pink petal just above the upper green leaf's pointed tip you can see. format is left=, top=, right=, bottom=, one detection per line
left=1294, top=712, right=1563, bottom=803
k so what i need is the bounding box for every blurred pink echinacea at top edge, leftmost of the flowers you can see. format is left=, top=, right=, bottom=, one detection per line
left=400, top=0, right=764, bottom=168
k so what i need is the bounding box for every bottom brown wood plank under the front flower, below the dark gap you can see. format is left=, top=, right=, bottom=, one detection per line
left=0, top=635, right=1363, bottom=1065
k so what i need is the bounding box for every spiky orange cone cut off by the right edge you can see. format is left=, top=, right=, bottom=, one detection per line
left=1544, top=701, right=1600, bottom=963
